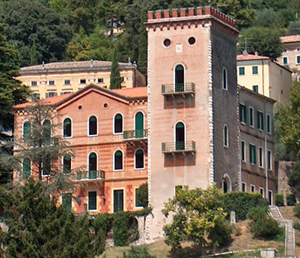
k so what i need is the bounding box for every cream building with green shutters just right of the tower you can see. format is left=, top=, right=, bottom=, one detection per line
left=237, top=54, right=292, bottom=102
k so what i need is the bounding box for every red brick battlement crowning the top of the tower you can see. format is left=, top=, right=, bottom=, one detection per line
left=148, top=6, right=237, bottom=29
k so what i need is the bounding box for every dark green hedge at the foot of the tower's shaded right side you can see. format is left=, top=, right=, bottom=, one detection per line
left=222, top=192, right=268, bottom=220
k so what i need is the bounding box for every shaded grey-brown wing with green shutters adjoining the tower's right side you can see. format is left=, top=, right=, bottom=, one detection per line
left=239, top=87, right=277, bottom=205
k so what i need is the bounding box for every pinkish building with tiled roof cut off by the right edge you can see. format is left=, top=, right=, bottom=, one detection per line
left=278, top=35, right=300, bottom=80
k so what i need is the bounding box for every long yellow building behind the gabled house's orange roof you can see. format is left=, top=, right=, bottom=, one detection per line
left=17, top=60, right=146, bottom=98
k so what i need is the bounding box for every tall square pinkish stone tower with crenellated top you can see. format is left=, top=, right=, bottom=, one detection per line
left=146, top=7, right=241, bottom=240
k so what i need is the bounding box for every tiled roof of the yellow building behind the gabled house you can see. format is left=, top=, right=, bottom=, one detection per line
left=20, top=60, right=136, bottom=74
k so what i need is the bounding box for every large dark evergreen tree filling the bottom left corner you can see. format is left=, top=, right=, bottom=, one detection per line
left=0, top=178, right=95, bottom=258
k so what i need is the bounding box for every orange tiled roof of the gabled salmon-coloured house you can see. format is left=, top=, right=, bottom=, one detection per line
left=14, top=84, right=147, bottom=109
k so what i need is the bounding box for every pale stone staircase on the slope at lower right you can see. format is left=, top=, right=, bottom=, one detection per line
left=270, top=206, right=295, bottom=257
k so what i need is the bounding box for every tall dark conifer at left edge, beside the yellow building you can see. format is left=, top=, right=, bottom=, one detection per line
left=0, top=24, right=29, bottom=133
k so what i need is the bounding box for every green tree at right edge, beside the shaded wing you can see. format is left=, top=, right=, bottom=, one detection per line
left=276, top=81, right=300, bottom=159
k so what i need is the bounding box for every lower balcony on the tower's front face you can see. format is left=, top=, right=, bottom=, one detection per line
left=162, top=141, right=196, bottom=155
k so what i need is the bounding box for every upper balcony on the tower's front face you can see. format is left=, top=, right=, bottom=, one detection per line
left=161, top=82, right=195, bottom=98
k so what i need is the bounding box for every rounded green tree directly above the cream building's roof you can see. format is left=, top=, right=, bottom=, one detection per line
left=238, top=27, right=283, bottom=60
